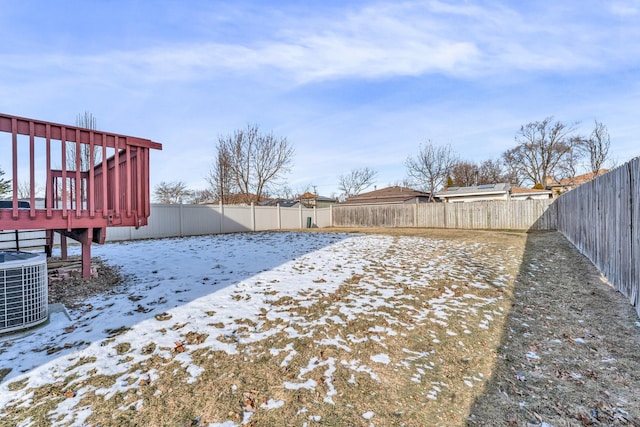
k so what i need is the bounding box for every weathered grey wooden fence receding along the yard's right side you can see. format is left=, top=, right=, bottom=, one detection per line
left=556, top=158, right=640, bottom=315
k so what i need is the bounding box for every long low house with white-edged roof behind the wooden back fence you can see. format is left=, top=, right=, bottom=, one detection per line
left=436, top=182, right=553, bottom=203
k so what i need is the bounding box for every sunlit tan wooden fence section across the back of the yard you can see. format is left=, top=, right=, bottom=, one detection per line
left=332, top=200, right=557, bottom=230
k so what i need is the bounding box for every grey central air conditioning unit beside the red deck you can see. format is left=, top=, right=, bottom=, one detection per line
left=0, top=251, right=49, bottom=334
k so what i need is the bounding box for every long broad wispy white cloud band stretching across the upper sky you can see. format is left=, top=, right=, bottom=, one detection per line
left=3, top=1, right=640, bottom=88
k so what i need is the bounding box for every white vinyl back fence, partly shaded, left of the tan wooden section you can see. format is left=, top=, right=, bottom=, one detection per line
left=106, top=204, right=331, bottom=241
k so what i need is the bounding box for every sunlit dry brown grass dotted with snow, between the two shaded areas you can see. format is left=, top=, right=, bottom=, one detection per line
left=5, top=230, right=635, bottom=426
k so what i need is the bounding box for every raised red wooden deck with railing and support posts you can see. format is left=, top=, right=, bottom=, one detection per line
left=0, top=113, right=162, bottom=277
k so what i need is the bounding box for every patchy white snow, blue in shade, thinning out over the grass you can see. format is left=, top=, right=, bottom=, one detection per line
left=0, top=233, right=512, bottom=426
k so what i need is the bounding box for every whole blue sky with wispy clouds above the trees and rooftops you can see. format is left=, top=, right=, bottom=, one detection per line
left=0, top=0, right=640, bottom=196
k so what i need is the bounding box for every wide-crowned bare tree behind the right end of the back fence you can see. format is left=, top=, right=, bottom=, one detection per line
left=503, top=117, right=580, bottom=188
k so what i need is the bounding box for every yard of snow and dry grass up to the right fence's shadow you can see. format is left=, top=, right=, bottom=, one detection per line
left=0, top=232, right=636, bottom=427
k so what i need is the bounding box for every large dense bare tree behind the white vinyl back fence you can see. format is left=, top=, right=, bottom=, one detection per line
left=213, top=125, right=294, bottom=203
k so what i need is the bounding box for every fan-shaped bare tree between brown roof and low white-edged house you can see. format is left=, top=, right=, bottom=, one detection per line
left=406, top=141, right=458, bottom=201
